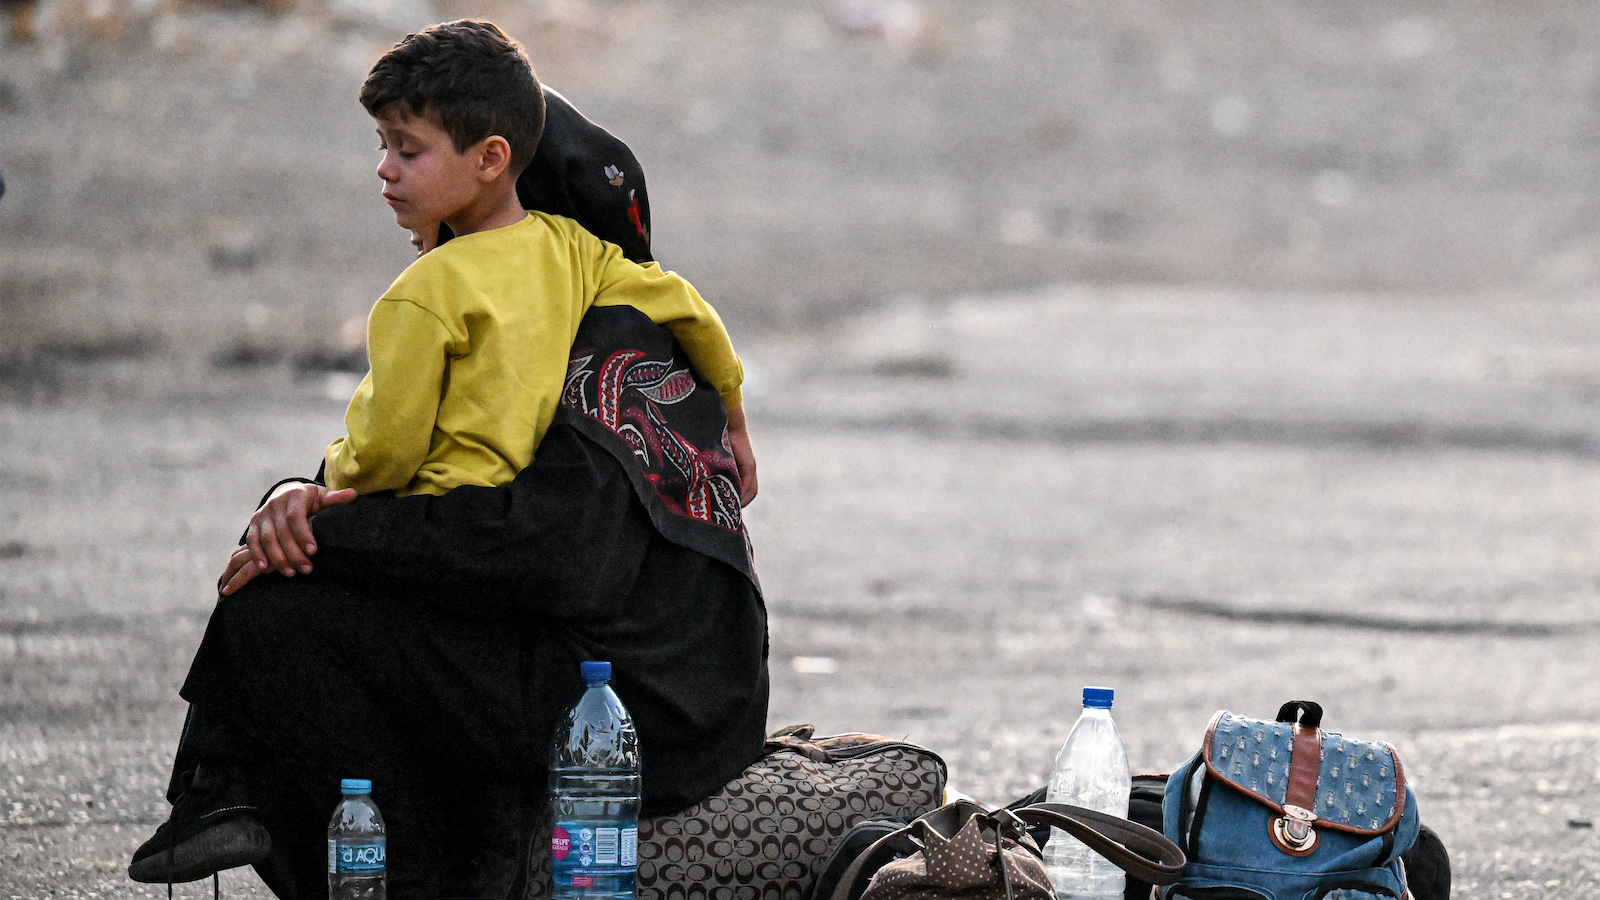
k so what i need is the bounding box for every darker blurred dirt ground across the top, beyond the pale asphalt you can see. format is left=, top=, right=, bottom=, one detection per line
left=9, top=0, right=1600, bottom=371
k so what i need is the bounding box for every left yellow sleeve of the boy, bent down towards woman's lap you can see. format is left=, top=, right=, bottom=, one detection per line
left=326, top=299, right=451, bottom=493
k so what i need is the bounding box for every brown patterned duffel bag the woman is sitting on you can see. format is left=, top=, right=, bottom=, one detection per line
left=525, top=725, right=949, bottom=900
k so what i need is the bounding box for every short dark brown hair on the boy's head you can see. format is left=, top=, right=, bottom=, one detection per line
left=362, top=19, right=544, bottom=175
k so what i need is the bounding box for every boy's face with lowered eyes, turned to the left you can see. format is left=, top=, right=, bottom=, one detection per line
left=376, top=107, right=483, bottom=229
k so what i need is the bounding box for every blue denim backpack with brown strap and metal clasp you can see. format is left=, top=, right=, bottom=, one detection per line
left=1162, top=700, right=1418, bottom=900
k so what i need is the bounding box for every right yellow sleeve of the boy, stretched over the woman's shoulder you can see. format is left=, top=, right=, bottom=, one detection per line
left=590, top=239, right=744, bottom=410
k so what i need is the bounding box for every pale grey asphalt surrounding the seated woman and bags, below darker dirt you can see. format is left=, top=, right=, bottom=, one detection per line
left=0, top=287, right=1600, bottom=898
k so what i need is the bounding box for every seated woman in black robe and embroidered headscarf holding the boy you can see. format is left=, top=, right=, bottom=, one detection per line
left=130, top=91, right=768, bottom=900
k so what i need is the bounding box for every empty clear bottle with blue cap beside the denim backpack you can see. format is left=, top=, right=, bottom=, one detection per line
left=1045, top=687, right=1133, bottom=900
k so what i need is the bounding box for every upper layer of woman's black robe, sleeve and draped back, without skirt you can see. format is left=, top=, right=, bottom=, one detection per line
left=307, top=423, right=768, bottom=815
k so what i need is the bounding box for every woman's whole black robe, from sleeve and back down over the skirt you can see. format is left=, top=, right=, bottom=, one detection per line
left=174, top=416, right=768, bottom=900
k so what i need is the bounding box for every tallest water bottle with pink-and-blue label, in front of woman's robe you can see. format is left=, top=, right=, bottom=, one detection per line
left=550, top=661, right=638, bottom=900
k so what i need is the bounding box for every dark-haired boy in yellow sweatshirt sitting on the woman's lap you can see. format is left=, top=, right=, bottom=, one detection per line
left=233, top=21, right=757, bottom=576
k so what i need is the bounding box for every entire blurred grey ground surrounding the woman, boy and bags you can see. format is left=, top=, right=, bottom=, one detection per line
left=0, top=0, right=1600, bottom=898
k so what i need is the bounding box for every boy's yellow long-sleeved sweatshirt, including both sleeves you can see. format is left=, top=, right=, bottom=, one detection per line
left=326, top=213, right=744, bottom=495
